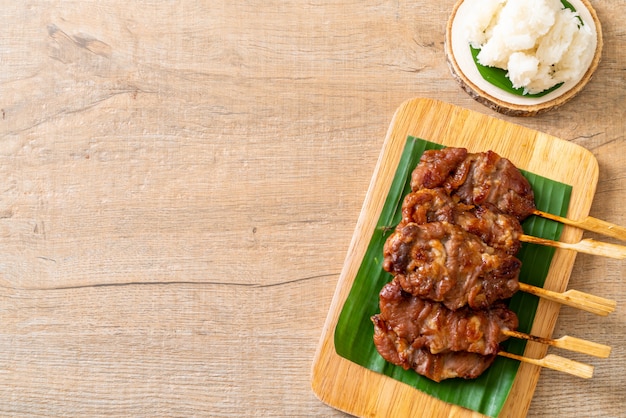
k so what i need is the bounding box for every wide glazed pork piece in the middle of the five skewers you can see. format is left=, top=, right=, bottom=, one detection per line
left=383, top=221, right=521, bottom=310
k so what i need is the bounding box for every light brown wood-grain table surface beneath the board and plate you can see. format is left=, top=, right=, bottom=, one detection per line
left=0, top=0, right=626, bottom=417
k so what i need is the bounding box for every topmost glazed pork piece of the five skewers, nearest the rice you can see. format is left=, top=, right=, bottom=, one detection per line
left=411, top=148, right=535, bottom=221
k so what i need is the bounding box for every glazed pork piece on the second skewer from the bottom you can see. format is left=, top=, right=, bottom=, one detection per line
left=372, top=280, right=518, bottom=355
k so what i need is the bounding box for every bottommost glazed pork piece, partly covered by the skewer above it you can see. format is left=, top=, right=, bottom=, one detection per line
left=372, top=317, right=496, bottom=382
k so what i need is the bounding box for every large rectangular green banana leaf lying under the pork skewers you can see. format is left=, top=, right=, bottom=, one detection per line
left=334, top=137, right=571, bottom=417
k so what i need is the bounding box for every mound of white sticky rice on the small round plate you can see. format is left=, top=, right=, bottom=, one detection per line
left=464, top=0, right=595, bottom=94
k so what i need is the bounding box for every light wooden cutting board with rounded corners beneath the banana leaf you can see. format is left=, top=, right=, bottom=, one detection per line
left=312, top=98, right=598, bottom=417
